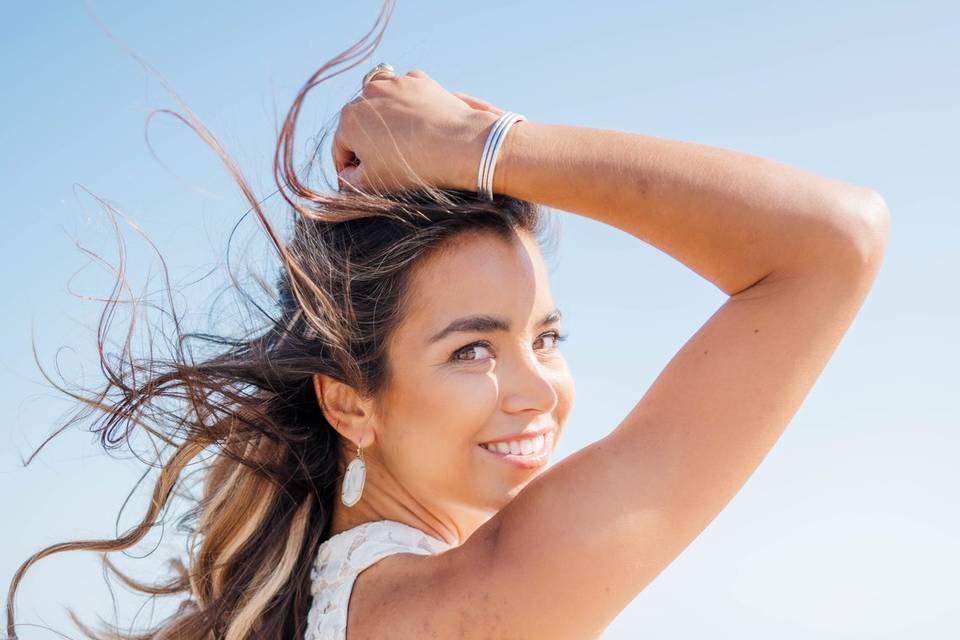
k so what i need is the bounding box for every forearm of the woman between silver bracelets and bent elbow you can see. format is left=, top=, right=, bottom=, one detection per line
left=465, top=112, right=888, bottom=295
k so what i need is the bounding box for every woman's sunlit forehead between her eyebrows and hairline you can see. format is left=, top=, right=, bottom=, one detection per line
left=403, top=232, right=554, bottom=334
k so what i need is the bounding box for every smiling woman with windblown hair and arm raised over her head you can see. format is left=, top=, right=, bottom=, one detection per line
left=8, top=8, right=889, bottom=640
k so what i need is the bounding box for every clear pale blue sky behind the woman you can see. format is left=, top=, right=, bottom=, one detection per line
left=0, top=0, right=960, bottom=640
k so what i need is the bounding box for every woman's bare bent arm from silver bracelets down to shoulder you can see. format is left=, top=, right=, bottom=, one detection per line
left=406, top=115, right=889, bottom=640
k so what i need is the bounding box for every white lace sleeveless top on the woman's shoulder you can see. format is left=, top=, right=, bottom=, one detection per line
left=303, top=520, right=450, bottom=640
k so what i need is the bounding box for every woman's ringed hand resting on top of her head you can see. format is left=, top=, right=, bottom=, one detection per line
left=333, top=69, right=503, bottom=191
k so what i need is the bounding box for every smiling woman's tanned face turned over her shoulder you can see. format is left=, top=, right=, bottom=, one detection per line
left=375, top=232, right=574, bottom=525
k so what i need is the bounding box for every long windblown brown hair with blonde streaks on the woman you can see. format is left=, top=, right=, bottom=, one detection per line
left=7, top=0, right=555, bottom=640
